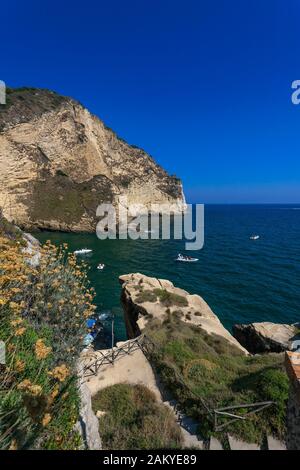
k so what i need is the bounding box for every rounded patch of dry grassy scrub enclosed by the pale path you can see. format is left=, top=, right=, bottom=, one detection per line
left=93, top=384, right=181, bottom=450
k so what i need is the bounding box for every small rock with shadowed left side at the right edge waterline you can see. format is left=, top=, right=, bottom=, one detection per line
left=233, top=322, right=300, bottom=354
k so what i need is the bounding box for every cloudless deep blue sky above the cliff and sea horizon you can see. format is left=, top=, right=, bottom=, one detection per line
left=0, top=0, right=300, bottom=203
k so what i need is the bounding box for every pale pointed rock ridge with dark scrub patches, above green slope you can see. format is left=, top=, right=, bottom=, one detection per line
left=119, top=273, right=248, bottom=354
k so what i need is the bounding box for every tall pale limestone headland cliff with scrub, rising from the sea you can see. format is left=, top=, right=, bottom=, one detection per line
left=0, top=89, right=184, bottom=231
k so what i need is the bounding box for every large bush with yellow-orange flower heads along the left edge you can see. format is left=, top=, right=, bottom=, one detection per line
left=0, top=236, right=94, bottom=449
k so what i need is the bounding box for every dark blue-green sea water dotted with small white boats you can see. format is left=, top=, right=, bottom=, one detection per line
left=35, top=205, right=300, bottom=341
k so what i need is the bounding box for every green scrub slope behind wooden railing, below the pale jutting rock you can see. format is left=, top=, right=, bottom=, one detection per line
left=146, top=315, right=289, bottom=443
